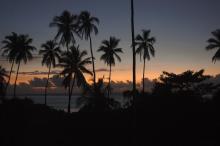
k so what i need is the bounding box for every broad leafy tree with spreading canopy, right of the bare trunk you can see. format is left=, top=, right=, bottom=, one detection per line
left=153, top=70, right=216, bottom=97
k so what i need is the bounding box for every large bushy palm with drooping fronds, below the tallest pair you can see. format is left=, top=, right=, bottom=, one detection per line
left=59, top=46, right=92, bottom=113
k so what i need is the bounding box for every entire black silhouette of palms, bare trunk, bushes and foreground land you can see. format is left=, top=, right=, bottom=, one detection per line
left=0, top=0, right=220, bottom=146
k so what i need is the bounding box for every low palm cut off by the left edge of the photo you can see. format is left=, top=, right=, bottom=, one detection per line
left=0, top=66, right=8, bottom=99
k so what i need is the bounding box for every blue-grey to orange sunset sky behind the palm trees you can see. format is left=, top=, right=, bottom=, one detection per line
left=0, top=0, right=220, bottom=81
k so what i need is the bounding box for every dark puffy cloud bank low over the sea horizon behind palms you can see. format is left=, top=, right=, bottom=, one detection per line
left=6, top=75, right=155, bottom=96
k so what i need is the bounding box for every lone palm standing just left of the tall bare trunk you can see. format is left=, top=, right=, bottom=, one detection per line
left=98, top=37, right=123, bottom=98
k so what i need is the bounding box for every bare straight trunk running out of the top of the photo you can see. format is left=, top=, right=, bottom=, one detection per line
left=131, top=0, right=136, bottom=98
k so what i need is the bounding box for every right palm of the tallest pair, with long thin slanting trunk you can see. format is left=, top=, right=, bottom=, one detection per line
left=78, top=11, right=99, bottom=86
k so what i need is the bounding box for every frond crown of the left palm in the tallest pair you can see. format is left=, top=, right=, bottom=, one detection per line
left=50, top=10, right=78, bottom=51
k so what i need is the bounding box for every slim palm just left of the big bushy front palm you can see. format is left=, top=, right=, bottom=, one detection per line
left=39, top=40, right=61, bottom=105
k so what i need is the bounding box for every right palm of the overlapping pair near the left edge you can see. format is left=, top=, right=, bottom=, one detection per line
left=13, top=34, right=36, bottom=97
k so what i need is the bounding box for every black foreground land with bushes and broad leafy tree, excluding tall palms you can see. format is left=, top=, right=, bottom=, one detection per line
left=0, top=70, right=220, bottom=146
